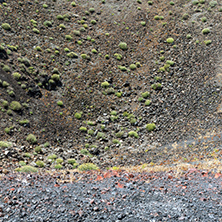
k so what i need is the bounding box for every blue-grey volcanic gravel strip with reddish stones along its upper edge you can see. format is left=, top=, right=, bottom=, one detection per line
left=0, top=168, right=222, bottom=222
